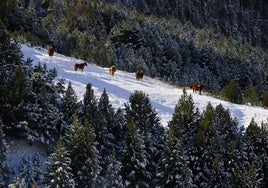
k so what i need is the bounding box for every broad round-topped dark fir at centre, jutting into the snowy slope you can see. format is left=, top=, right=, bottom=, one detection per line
left=125, top=91, right=165, bottom=186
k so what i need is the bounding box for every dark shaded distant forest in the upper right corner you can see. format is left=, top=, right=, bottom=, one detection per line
left=113, top=0, right=268, bottom=49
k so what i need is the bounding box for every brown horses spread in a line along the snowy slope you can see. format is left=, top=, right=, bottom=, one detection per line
left=48, top=45, right=206, bottom=95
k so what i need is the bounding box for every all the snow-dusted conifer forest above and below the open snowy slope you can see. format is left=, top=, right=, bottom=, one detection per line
left=0, top=0, right=268, bottom=188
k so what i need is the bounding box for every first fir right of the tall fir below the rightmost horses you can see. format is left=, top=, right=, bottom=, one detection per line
left=194, top=103, right=230, bottom=187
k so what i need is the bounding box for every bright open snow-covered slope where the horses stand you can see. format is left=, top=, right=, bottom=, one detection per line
left=21, top=45, right=268, bottom=127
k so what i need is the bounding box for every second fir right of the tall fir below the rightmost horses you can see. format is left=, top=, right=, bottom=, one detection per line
left=206, top=105, right=259, bottom=187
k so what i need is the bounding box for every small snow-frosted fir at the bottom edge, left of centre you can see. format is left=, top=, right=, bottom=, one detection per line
left=47, top=139, right=76, bottom=188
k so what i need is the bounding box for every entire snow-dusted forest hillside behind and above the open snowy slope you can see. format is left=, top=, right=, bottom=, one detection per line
left=1, top=0, right=268, bottom=106
